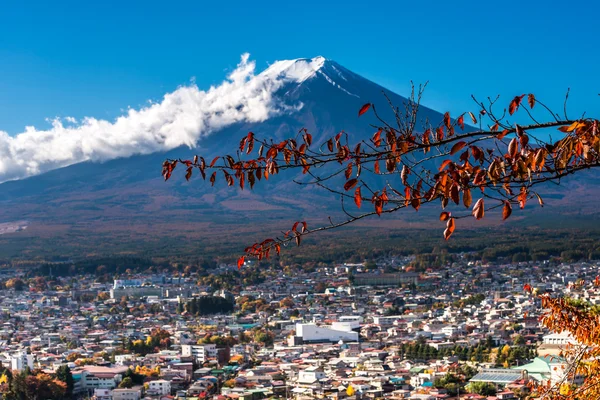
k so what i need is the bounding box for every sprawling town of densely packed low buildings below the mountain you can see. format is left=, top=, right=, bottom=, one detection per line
left=0, top=257, right=600, bottom=400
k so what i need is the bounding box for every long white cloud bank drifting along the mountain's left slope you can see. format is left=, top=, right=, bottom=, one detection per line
left=0, top=54, right=302, bottom=182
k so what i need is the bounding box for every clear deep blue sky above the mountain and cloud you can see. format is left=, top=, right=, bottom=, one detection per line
left=0, top=0, right=600, bottom=134
